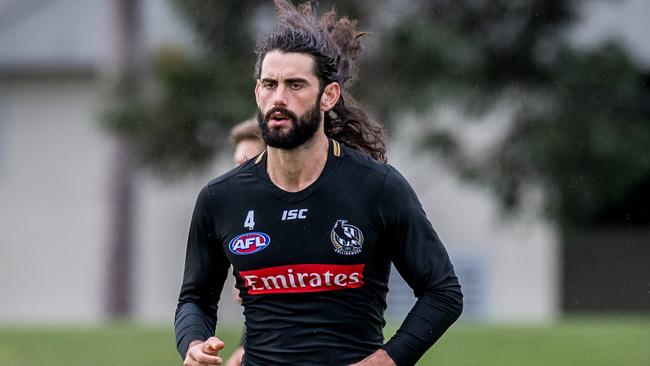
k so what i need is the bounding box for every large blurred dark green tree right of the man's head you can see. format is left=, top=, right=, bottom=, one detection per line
left=373, top=0, right=650, bottom=228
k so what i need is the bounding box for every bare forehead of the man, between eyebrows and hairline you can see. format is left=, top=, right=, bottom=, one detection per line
left=261, top=51, right=316, bottom=79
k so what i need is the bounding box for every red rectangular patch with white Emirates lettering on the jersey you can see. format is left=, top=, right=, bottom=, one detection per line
left=239, top=264, right=364, bottom=295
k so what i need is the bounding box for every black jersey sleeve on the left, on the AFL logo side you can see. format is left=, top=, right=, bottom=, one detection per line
left=174, top=187, right=230, bottom=358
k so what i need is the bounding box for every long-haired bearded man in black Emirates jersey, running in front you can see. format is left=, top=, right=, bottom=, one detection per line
left=175, top=0, right=462, bottom=366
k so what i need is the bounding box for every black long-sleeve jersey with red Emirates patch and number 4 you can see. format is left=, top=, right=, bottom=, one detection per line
left=175, top=140, right=462, bottom=366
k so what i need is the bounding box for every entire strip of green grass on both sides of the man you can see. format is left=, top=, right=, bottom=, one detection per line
left=0, top=317, right=650, bottom=366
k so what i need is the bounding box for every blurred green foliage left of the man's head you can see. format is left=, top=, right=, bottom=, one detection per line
left=106, top=0, right=255, bottom=179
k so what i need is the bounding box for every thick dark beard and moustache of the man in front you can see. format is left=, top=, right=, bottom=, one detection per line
left=257, top=98, right=321, bottom=150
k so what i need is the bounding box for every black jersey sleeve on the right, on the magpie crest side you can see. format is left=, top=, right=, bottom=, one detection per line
left=380, top=166, right=463, bottom=366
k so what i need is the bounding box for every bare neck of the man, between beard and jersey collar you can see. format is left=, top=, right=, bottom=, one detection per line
left=266, top=132, right=329, bottom=192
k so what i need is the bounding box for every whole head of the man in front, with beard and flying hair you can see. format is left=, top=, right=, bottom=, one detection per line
left=255, top=0, right=386, bottom=161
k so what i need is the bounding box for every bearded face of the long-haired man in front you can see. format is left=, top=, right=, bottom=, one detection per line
left=255, top=51, right=322, bottom=149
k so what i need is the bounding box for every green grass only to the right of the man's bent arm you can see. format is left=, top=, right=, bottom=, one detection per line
left=410, top=318, right=650, bottom=366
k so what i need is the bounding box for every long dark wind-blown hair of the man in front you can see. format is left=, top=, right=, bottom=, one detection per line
left=255, top=0, right=387, bottom=163
